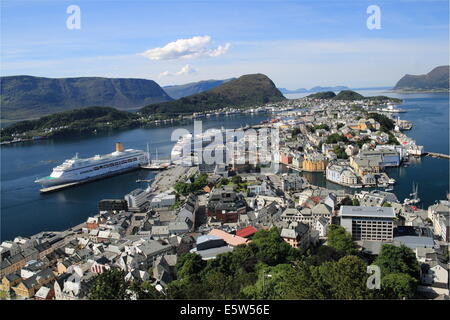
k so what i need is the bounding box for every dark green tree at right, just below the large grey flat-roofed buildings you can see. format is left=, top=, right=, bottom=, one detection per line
left=374, top=244, right=419, bottom=279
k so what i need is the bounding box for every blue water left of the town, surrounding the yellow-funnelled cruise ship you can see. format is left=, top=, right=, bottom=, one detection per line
left=0, top=114, right=268, bottom=240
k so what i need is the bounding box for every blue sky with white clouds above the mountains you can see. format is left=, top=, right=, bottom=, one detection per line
left=0, top=0, right=449, bottom=89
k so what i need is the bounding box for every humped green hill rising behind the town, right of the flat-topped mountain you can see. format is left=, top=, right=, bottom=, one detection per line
left=140, top=73, right=286, bottom=116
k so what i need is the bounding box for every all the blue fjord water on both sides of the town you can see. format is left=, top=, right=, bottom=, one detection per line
left=0, top=91, right=450, bottom=240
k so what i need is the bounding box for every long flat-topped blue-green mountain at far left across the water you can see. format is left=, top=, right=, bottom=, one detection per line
left=0, top=76, right=172, bottom=120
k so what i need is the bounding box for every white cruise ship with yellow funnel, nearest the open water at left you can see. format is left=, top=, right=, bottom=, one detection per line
left=35, top=142, right=148, bottom=188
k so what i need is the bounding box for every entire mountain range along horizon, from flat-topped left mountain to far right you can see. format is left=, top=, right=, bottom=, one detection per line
left=0, top=66, right=449, bottom=120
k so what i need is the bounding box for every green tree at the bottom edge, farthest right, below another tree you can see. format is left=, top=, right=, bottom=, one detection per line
left=381, top=273, right=417, bottom=299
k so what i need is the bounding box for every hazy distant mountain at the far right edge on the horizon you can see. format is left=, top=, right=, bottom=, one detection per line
left=394, top=66, right=449, bottom=91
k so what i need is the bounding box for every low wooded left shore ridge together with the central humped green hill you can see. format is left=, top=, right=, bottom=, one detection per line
left=1, top=74, right=286, bottom=141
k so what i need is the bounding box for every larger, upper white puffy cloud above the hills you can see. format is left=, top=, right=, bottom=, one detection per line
left=139, top=36, right=230, bottom=60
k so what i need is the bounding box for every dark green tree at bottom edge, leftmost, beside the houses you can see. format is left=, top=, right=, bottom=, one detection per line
left=88, top=268, right=129, bottom=300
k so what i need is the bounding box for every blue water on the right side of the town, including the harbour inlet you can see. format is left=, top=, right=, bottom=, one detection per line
left=288, top=90, right=450, bottom=209
